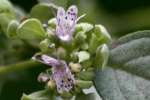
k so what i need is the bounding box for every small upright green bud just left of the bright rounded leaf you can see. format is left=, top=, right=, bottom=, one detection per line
left=6, top=20, right=19, bottom=38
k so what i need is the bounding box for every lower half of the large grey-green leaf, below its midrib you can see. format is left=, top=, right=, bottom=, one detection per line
left=94, top=67, right=150, bottom=100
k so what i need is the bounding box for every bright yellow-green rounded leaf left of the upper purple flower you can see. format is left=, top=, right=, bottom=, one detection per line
left=17, top=18, right=46, bottom=40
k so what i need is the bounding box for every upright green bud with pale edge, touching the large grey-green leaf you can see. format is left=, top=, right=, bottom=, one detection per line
left=94, top=44, right=109, bottom=68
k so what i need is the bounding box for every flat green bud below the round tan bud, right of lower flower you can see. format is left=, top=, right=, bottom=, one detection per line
left=76, top=71, right=95, bottom=81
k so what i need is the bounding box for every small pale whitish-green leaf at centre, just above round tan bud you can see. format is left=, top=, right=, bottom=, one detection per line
left=78, top=51, right=90, bottom=63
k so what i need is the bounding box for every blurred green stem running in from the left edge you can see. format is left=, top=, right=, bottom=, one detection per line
left=0, top=60, right=39, bottom=75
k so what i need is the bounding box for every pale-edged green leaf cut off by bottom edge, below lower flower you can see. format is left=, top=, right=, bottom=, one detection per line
left=21, top=90, right=54, bottom=100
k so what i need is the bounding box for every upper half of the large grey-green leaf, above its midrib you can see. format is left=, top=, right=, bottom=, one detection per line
left=108, top=31, right=150, bottom=79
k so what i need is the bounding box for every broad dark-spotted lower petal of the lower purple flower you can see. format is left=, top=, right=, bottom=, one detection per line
left=53, top=61, right=75, bottom=93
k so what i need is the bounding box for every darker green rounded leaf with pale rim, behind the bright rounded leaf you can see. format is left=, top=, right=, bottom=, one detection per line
left=30, top=3, right=57, bottom=22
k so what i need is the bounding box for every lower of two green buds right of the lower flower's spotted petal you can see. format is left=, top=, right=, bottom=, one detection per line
left=76, top=80, right=93, bottom=89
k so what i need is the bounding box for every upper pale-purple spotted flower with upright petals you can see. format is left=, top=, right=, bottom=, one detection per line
left=56, top=5, right=84, bottom=41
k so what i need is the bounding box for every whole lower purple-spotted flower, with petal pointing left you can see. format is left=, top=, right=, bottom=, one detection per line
left=33, top=55, right=75, bottom=93
